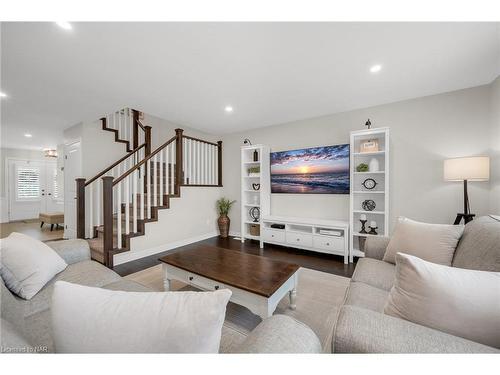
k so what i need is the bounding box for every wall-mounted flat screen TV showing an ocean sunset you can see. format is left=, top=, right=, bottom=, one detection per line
left=271, top=144, right=350, bottom=194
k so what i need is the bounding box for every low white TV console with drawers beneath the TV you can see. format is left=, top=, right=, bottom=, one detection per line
left=260, top=215, right=349, bottom=264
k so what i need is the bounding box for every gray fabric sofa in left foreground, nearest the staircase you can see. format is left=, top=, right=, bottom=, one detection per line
left=0, top=240, right=321, bottom=353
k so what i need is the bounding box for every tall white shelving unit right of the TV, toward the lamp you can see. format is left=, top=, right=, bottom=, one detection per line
left=349, top=128, right=390, bottom=262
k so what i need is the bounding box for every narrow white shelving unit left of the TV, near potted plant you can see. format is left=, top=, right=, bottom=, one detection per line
left=240, top=145, right=271, bottom=247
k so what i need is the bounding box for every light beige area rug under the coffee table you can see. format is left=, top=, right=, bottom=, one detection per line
left=125, top=265, right=349, bottom=353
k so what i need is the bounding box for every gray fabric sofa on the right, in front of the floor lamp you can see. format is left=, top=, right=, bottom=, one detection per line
left=332, top=216, right=500, bottom=353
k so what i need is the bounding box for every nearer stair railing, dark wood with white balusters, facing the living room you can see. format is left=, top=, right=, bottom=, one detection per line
left=98, top=129, right=222, bottom=268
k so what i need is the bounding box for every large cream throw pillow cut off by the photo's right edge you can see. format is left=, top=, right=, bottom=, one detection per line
left=384, top=253, right=500, bottom=348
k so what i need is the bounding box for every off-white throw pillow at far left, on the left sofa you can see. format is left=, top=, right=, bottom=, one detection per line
left=0, top=232, right=67, bottom=300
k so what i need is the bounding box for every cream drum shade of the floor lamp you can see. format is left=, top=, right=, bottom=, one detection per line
left=444, top=156, right=490, bottom=181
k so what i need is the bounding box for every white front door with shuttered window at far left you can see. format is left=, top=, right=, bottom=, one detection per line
left=8, top=160, right=62, bottom=221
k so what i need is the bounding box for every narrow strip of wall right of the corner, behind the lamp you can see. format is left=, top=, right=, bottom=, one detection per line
left=490, top=77, right=500, bottom=215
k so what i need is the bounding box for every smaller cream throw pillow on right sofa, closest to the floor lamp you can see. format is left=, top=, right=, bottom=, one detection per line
left=384, top=217, right=464, bottom=266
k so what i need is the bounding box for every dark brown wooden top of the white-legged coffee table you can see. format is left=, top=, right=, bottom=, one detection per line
left=160, top=245, right=299, bottom=297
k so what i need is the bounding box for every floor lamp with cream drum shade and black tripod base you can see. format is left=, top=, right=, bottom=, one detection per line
left=444, top=156, right=490, bottom=225
